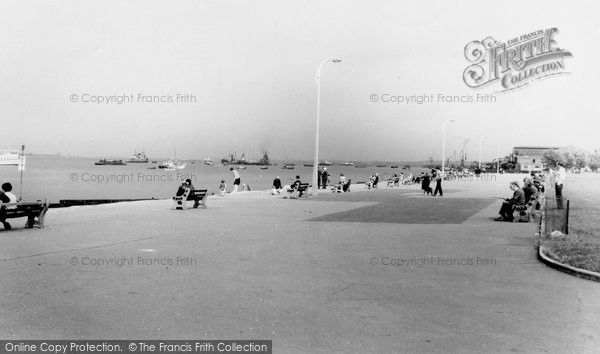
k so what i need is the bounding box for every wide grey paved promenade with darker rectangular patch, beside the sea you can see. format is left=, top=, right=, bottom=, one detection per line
left=0, top=175, right=600, bottom=353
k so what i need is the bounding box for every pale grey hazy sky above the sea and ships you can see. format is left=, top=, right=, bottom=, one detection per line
left=0, top=0, right=600, bottom=161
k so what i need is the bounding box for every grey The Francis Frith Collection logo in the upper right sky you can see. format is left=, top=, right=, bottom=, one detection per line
left=463, top=28, right=571, bottom=91
